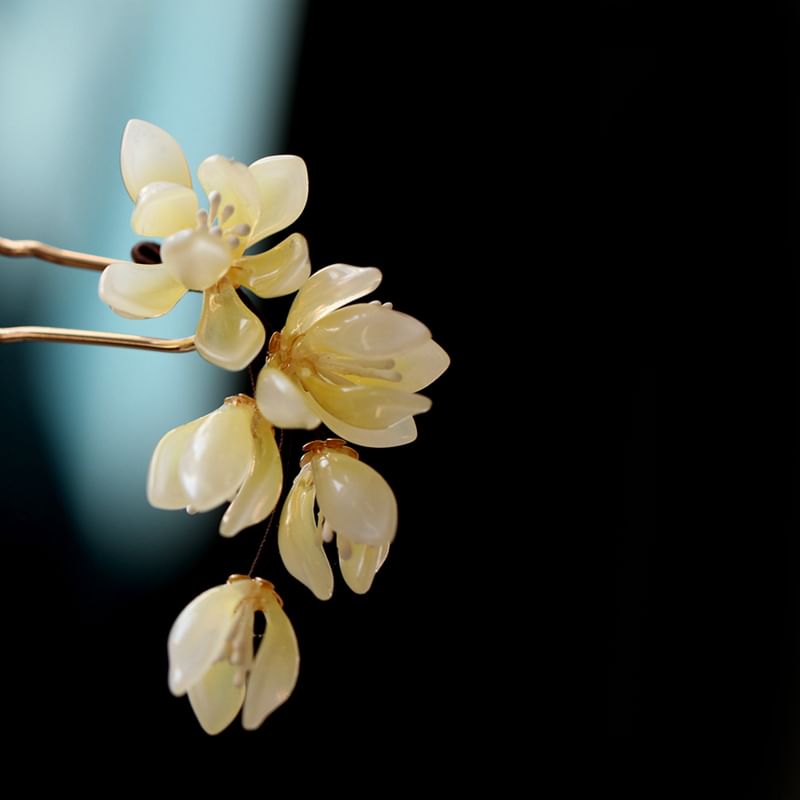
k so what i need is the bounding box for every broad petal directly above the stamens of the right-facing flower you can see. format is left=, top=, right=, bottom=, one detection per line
left=305, top=303, right=431, bottom=358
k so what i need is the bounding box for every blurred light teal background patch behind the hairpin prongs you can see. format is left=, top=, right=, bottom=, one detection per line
left=0, top=0, right=305, bottom=580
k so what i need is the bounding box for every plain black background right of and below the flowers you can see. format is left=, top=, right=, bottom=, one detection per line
left=25, top=2, right=800, bottom=800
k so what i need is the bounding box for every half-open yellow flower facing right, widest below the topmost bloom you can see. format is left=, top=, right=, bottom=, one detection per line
left=256, top=264, right=450, bottom=447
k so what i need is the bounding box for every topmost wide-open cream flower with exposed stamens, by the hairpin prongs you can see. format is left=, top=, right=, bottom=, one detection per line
left=99, top=119, right=311, bottom=370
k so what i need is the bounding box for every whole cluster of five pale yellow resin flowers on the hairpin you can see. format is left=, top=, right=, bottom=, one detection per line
left=99, top=120, right=449, bottom=734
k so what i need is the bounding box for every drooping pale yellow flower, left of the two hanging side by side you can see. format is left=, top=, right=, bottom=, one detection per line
left=147, top=395, right=283, bottom=536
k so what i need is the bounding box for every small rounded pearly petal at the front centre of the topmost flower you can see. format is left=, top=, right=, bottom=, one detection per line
left=161, top=229, right=231, bottom=291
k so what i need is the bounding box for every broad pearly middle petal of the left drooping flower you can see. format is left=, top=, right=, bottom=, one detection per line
left=178, top=405, right=254, bottom=511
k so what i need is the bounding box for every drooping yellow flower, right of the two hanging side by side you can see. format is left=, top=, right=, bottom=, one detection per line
left=278, top=439, right=397, bottom=600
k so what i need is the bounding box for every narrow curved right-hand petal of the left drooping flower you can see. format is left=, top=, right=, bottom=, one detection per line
left=219, top=414, right=283, bottom=536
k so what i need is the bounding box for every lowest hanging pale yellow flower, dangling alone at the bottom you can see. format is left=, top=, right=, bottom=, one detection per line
left=167, top=575, right=300, bottom=735
